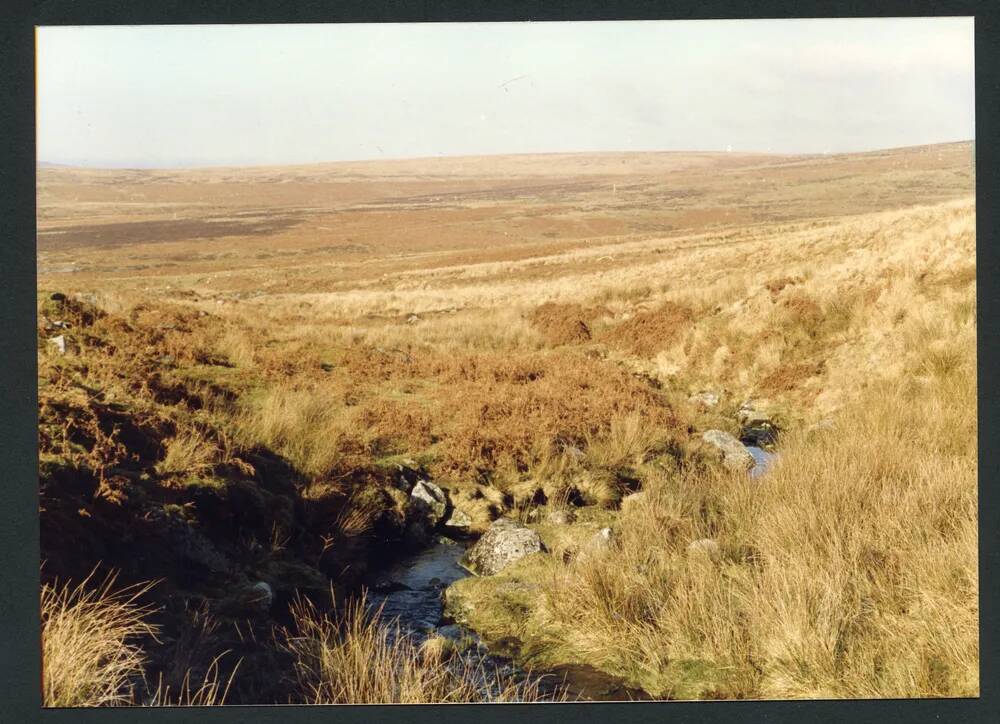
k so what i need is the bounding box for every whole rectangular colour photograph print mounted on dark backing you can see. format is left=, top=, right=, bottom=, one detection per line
left=37, top=16, right=976, bottom=704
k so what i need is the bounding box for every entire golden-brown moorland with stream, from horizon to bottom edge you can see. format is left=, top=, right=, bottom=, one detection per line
left=38, top=143, right=979, bottom=705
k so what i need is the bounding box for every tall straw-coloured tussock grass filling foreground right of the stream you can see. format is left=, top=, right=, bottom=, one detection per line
left=538, top=346, right=978, bottom=698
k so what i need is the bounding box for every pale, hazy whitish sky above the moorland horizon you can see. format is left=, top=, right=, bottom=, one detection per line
left=37, top=18, right=975, bottom=168
